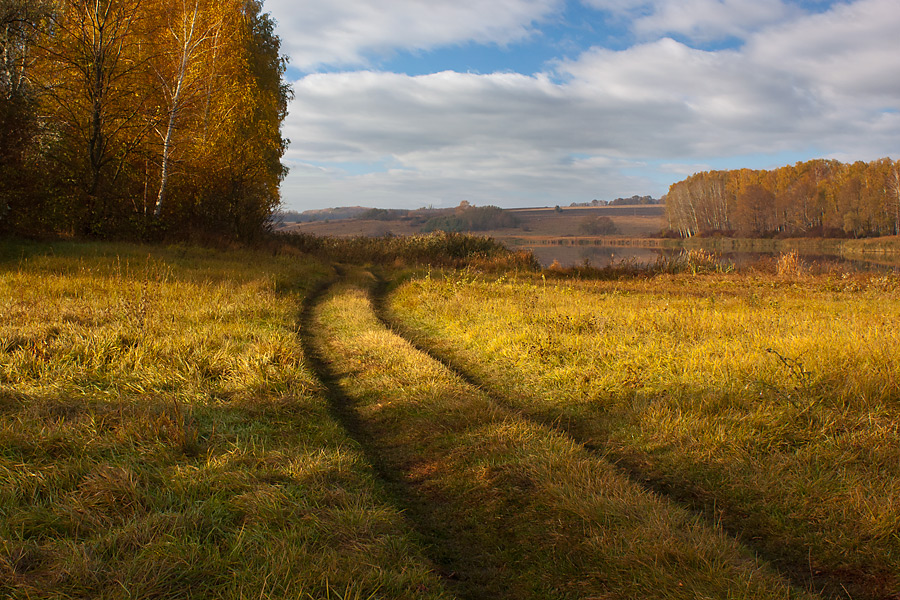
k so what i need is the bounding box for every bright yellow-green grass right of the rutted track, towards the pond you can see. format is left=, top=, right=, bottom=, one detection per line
left=390, top=258, right=900, bottom=599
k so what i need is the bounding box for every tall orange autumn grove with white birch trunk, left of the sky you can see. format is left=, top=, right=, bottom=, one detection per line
left=0, top=0, right=290, bottom=238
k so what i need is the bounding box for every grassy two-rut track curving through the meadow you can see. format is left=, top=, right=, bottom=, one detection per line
left=303, top=274, right=814, bottom=599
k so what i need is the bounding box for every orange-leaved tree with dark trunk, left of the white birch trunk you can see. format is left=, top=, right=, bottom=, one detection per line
left=37, top=0, right=154, bottom=234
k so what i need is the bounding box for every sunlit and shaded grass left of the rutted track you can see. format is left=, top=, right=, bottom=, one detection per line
left=0, top=242, right=449, bottom=599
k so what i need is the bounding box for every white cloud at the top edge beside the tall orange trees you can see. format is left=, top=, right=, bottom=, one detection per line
left=265, top=0, right=564, bottom=70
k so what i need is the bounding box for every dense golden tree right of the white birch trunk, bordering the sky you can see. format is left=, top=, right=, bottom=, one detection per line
left=158, top=1, right=290, bottom=237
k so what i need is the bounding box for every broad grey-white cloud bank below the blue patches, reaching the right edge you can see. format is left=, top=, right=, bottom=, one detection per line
left=274, top=0, right=900, bottom=207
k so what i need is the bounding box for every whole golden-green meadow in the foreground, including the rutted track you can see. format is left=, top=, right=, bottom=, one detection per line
left=0, top=236, right=900, bottom=600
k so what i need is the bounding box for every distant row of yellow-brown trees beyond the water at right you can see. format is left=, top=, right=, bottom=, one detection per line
left=665, top=158, right=900, bottom=237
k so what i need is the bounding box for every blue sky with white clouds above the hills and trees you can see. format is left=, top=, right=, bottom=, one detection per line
left=264, top=0, right=900, bottom=211
